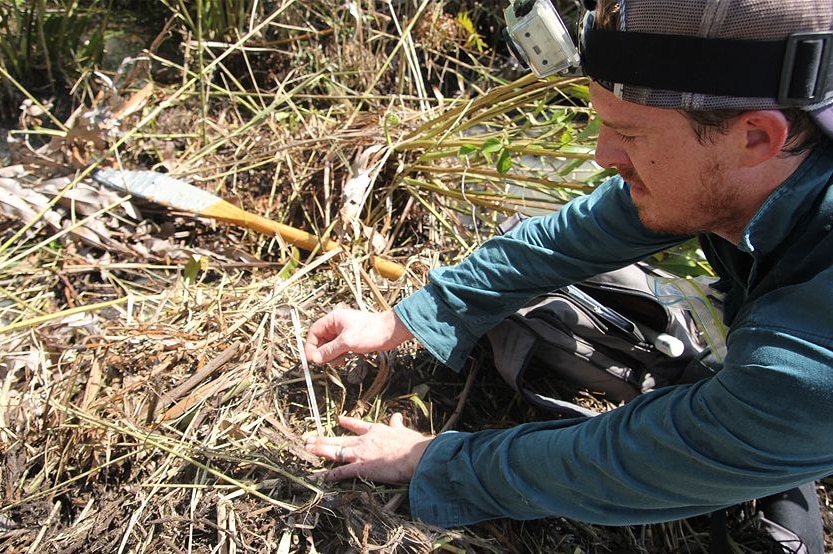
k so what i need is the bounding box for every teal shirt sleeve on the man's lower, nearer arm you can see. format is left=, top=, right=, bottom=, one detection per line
left=410, top=283, right=833, bottom=527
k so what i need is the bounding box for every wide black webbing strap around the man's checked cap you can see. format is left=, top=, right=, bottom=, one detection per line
left=582, top=29, right=833, bottom=105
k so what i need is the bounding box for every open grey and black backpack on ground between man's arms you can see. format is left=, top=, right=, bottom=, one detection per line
left=485, top=263, right=725, bottom=417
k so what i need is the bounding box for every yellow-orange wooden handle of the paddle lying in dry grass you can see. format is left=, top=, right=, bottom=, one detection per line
left=205, top=200, right=405, bottom=281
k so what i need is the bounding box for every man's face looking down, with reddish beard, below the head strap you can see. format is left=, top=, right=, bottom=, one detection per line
left=590, top=83, right=743, bottom=234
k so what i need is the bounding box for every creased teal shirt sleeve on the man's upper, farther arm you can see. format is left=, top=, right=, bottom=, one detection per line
left=394, top=176, right=689, bottom=370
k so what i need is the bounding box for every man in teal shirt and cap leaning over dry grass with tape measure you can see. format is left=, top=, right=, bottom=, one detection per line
left=306, top=0, right=833, bottom=552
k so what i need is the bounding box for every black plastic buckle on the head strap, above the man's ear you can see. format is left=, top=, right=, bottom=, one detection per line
left=778, top=31, right=833, bottom=106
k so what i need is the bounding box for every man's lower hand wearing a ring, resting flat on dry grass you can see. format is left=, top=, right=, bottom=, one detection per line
left=306, top=413, right=434, bottom=484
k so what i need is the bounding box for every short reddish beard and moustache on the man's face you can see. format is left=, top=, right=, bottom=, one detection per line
left=619, top=161, right=745, bottom=235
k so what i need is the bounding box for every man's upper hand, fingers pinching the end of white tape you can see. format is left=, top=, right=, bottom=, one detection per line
left=304, top=308, right=413, bottom=364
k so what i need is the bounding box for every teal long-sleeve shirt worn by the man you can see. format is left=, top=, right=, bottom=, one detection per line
left=395, top=142, right=833, bottom=527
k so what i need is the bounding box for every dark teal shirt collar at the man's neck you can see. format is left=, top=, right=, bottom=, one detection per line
left=738, top=141, right=833, bottom=259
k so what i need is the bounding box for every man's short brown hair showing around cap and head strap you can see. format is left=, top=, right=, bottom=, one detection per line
left=595, top=0, right=826, bottom=156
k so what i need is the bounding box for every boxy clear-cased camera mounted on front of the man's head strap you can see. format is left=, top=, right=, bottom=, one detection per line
left=503, top=0, right=580, bottom=78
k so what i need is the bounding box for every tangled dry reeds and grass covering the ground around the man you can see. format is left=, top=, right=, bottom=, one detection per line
left=0, top=0, right=832, bottom=554
